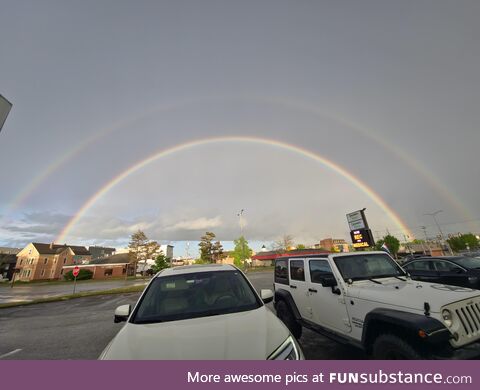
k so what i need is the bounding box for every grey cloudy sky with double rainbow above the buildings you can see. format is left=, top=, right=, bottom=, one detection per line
left=0, top=0, right=480, bottom=255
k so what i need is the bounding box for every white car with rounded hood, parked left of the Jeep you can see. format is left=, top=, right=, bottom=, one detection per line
left=100, top=264, right=303, bottom=360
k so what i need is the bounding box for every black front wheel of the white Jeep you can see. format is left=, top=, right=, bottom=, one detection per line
left=372, top=334, right=423, bottom=360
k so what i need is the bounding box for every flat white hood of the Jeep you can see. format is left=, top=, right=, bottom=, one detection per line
left=347, top=278, right=480, bottom=313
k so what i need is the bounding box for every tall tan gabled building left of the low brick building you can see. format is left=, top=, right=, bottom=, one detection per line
left=15, top=242, right=91, bottom=282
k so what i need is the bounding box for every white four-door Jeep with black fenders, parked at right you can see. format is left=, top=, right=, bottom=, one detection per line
left=275, top=252, right=480, bottom=359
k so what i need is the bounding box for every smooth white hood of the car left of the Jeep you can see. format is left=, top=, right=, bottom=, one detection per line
left=100, top=306, right=290, bottom=360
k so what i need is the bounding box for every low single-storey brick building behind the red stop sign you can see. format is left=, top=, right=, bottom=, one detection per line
left=62, top=253, right=134, bottom=280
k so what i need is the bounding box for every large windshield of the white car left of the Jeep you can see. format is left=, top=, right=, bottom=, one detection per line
left=132, top=271, right=262, bottom=324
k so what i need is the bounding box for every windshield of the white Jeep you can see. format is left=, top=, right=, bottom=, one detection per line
left=335, top=254, right=405, bottom=281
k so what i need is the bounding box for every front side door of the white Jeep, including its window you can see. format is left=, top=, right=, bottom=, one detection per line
left=308, top=259, right=352, bottom=333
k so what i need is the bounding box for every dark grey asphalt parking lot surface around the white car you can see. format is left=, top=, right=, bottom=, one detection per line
left=0, top=272, right=365, bottom=359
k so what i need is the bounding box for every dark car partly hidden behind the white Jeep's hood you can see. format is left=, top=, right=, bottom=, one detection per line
left=403, top=256, right=480, bottom=289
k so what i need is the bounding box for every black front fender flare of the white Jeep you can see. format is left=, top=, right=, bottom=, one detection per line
left=362, top=308, right=451, bottom=349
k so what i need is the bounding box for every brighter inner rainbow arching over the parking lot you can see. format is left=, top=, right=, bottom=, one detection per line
left=55, top=136, right=414, bottom=242
